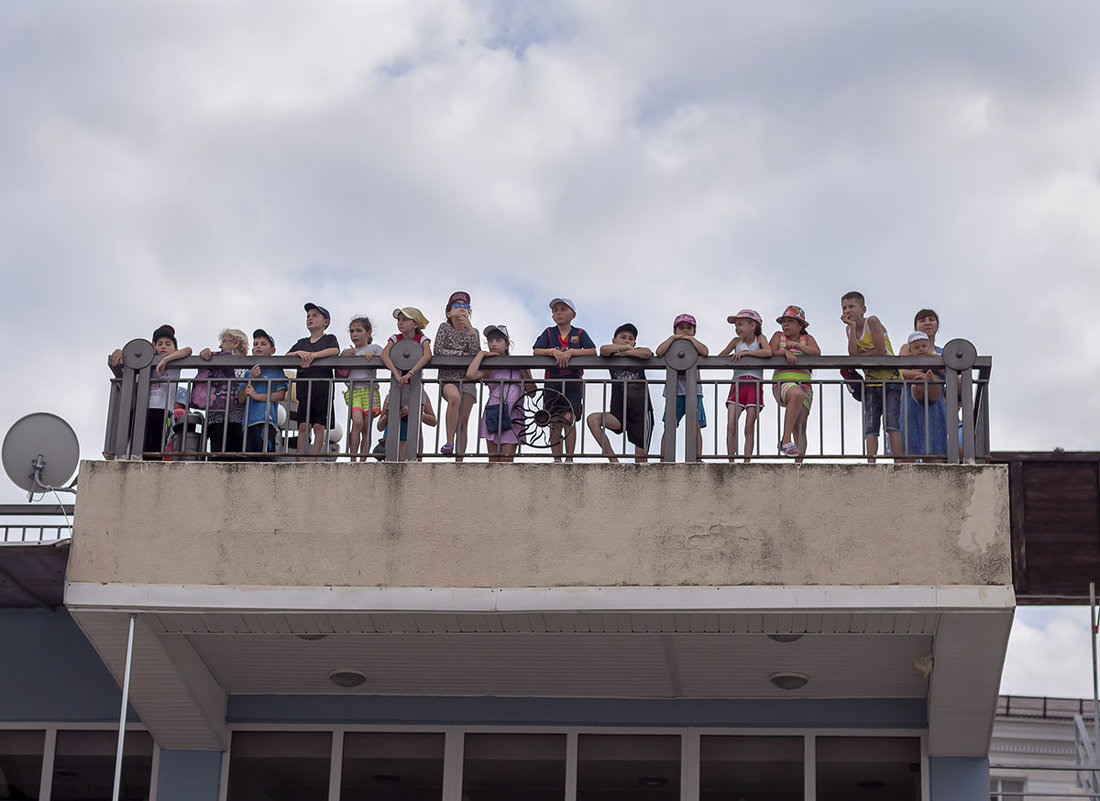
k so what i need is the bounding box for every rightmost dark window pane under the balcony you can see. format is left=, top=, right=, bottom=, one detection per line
left=817, top=737, right=921, bottom=801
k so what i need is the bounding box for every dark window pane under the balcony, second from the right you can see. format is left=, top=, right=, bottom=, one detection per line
left=699, top=735, right=805, bottom=801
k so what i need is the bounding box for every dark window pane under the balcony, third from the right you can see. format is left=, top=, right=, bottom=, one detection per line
left=576, top=734, right=680, bottom=801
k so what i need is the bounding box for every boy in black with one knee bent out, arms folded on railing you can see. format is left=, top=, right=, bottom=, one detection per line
left=589, top=322, right=653, bottom=464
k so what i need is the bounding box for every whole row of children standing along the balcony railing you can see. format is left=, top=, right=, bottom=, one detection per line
left=109, top=292, right=946, bottom=462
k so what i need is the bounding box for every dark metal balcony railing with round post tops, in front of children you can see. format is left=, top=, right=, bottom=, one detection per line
left=103, top=340, right=991, bottom=463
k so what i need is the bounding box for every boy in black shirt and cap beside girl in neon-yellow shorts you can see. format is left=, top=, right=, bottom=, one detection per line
left=287, top=304, right=340, bottom=458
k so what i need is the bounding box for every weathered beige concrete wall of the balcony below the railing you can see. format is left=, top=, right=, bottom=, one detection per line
left=68, top=461, right=1011, bottom=588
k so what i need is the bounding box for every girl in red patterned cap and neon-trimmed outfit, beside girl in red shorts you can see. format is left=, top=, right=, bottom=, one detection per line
left=768, top=306, right=822, bottom=462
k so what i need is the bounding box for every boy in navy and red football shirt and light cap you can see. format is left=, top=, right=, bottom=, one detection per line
left=534, top=297, right=596, bottom=462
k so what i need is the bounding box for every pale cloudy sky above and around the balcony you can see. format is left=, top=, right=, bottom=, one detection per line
left=0, top=0, right=1100, bottom=695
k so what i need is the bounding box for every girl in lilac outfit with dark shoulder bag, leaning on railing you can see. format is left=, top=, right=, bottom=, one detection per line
left=466, top=326, right=535, bottom=462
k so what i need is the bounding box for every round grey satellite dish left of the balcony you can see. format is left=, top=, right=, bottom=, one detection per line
left=3, top=412, right=80, bottom=495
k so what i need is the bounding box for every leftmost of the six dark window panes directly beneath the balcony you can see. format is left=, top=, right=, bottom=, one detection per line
left=227, top=732, right=332, bottom=801
